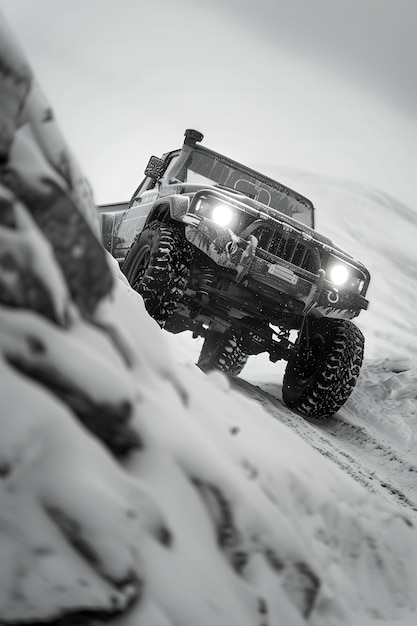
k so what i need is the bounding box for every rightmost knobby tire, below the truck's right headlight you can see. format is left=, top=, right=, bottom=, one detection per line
left=282, top=318, right=364, bottom=420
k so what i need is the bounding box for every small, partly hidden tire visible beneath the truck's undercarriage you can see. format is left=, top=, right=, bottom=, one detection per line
left=197, top=332, right=249, bottom=376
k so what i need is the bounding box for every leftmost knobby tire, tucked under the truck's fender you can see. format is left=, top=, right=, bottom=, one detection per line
left=123, top=222, right=192, bottom=327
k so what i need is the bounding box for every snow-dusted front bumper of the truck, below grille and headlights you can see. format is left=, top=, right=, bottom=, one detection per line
left=183, top=213, right=368, bottom=319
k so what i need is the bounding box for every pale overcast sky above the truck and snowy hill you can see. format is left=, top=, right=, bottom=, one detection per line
left=0, top=0, right=417, bottom=206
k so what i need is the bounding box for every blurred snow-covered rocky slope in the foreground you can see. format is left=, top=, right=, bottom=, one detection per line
left=0, top=8, right=417, bottom=626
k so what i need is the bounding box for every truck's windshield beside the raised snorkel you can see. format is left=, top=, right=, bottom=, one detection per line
left=171, top=148, right=314, bottom=227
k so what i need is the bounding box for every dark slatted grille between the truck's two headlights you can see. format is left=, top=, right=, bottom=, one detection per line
left=252, top=225, right=320, bottom=274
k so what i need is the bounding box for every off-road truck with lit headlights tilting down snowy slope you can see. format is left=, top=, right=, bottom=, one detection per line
left=102, top=130, right=370, bottom=419
